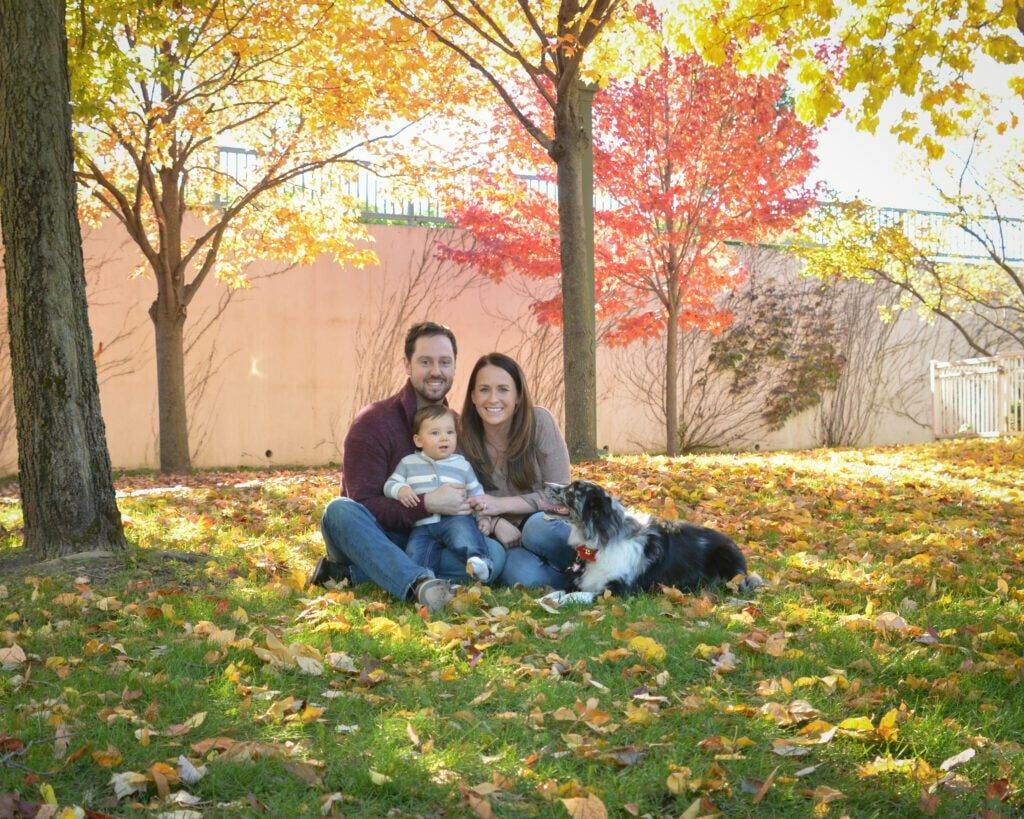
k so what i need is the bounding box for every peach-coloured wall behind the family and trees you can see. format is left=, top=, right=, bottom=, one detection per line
left=0, top=222, right=946, bottom=473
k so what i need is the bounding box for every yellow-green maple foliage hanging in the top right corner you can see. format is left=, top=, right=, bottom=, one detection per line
left=658, top=0, right=1024, bottom=159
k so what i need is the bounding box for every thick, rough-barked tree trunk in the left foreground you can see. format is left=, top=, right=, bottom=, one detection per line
left=0, top=0, right=125, bottom=558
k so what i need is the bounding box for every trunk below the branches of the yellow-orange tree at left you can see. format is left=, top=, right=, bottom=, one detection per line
left=150, top=294, right=191, bottom=473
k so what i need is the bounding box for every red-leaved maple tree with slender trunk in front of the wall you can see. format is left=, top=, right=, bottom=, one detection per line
left=445, top=12, right=816, bottom=455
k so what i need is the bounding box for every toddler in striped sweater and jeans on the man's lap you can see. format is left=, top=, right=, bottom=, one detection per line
left=384, top=404, right=494, bottom=583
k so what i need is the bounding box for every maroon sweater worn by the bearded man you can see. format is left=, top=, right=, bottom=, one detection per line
left=341, top=381, right=446, bottom=529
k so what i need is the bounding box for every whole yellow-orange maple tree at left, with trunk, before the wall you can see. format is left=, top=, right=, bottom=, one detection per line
left=67, top=0, right=462, bottom=472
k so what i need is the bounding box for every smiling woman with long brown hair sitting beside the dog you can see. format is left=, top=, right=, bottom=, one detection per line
left=459, top=352, right=574, bottom=589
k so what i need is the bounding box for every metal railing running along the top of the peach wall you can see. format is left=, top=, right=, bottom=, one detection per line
left=219, top=147, right=1024, bottom=264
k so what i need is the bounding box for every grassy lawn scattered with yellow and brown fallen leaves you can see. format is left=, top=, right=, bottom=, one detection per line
left=0, top=440, right=1024, bottom=817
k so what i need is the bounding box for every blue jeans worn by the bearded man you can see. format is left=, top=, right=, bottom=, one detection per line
left=321, top=498, right=505, bottom=600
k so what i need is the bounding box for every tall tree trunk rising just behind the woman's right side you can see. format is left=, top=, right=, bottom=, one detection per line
left=551, top=84, right=597, bottom=462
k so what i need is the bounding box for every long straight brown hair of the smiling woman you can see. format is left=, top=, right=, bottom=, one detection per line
left=460, top=352, right=538, bottom=491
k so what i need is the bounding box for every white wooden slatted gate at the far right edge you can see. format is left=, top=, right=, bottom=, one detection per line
left=931, top=353, right=1024, bottom=438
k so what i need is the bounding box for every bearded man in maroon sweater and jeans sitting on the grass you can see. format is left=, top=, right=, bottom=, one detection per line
left=307, top=321, right=505, bottom=611
